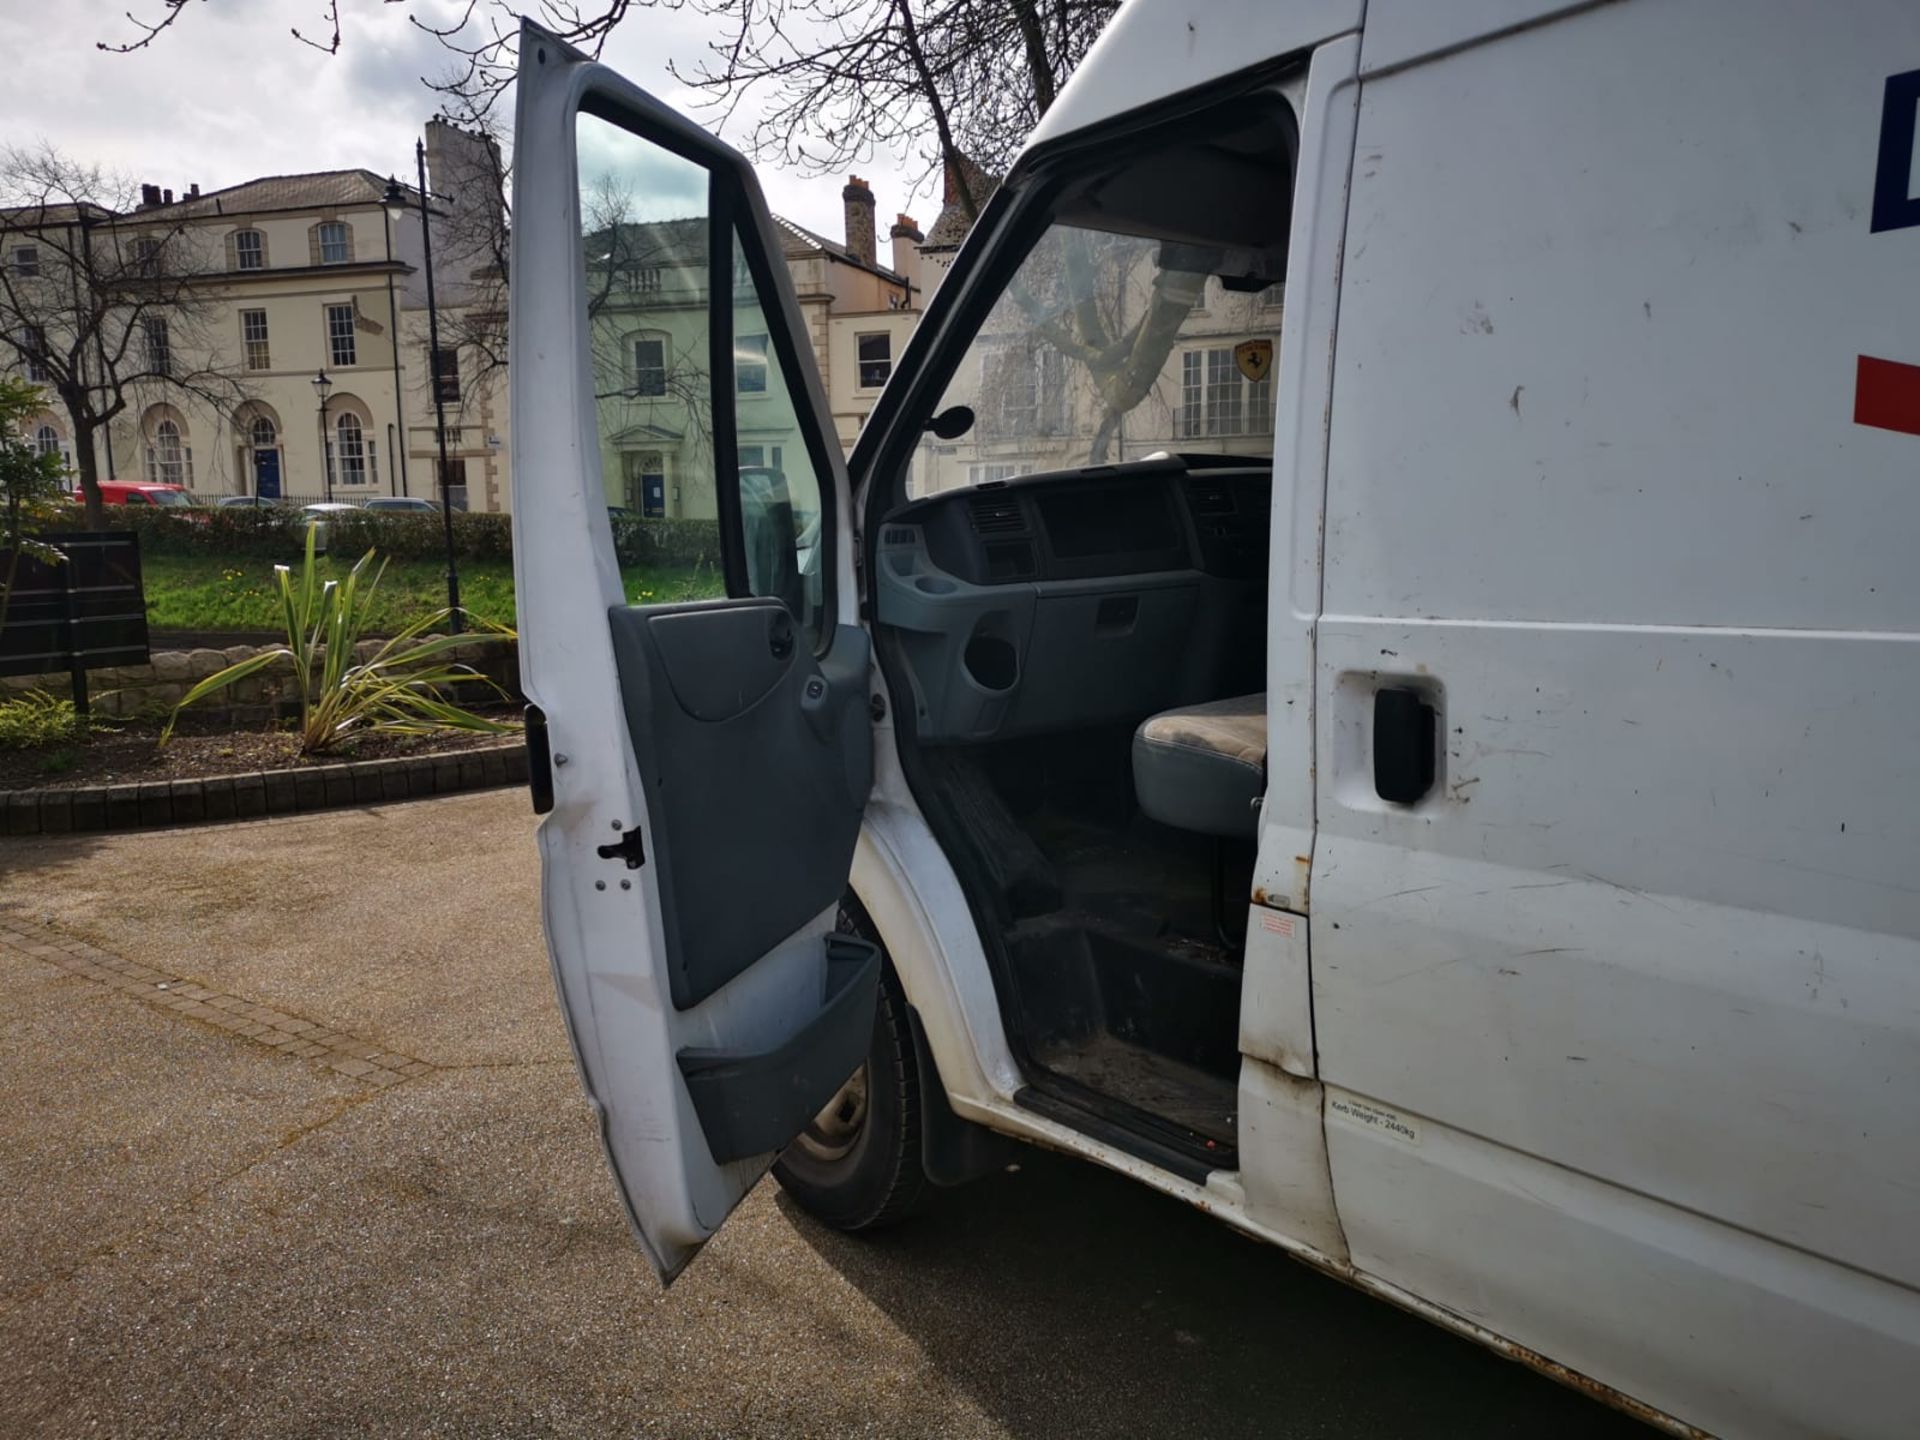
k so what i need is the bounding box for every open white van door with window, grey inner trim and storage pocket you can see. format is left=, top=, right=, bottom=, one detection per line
left=511, top=25, right=879, bottom=1279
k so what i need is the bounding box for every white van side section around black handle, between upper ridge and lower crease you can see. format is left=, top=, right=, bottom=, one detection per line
left=1313, top=618, right=1920, bottom=1286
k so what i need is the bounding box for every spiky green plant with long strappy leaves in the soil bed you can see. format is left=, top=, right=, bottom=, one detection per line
left=159, top=524, right=518, bottom=755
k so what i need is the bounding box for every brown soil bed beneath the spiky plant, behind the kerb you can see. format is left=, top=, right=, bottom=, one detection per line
left=0, top=712, right=516, bottom=791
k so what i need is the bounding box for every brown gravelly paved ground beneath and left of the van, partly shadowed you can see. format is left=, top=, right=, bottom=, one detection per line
left=0, top=793, right=1644, bottom=1438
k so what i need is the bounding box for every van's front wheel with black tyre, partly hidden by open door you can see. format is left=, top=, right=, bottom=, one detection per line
left=774, top=895, right=929, bottom=1231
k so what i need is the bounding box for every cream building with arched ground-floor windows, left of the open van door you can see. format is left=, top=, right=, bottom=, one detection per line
left=5, top=121, right=509, bottom=509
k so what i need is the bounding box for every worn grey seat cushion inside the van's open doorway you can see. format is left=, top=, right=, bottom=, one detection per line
left=1133, top=693, right=1267, bottom=837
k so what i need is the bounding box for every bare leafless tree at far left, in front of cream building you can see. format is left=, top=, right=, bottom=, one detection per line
left=0, top=148, right=259, bottom=528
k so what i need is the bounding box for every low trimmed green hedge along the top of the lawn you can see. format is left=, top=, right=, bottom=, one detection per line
left=43, top=505, right=720, bottom=568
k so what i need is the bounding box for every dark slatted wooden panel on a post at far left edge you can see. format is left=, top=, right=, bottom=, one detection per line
left=0, top=530, right=148, bottom=714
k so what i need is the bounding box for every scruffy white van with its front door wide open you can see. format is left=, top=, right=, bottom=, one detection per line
left=513, top=0, right=1920, bottom=1438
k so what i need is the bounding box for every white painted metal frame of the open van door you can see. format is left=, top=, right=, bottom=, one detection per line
left=511, top=28, right=856, bottom=1279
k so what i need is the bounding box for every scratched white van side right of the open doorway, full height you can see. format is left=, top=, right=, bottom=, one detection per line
left=1311, top=2, right=1920, bottom=1436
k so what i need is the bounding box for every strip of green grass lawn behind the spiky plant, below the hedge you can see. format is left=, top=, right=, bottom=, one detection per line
left=140, top=555, right=724, bottom=632
